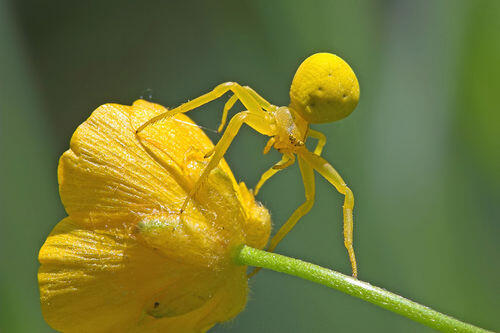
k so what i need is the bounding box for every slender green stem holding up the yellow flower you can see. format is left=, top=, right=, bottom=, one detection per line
left=234, top=245, right=488, bottom=332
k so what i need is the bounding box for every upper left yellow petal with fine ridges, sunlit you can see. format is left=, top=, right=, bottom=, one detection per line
left=58, top=104, right=184, bottom=224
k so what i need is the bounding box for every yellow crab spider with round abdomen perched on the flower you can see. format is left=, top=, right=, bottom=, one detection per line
left=137, top=53, right=359, bottom=277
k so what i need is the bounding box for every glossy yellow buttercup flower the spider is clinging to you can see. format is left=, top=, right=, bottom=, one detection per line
left=38, top=100, right=270, bottom=332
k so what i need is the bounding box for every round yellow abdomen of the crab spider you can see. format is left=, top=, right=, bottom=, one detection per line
left=290, top=53, right=359, bottom=124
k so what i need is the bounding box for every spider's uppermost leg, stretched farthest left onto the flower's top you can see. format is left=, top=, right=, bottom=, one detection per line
left=136, top=82, right=268, bottom=133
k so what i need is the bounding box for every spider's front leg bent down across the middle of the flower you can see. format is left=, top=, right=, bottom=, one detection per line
left=180, top=111, right=272, bottom=213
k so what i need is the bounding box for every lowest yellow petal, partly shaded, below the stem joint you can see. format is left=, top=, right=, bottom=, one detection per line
left=38, top=218, right=246, bottom=332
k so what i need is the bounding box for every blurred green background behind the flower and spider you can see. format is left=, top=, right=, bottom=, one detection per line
left=0, top=0, right=500, bottom=332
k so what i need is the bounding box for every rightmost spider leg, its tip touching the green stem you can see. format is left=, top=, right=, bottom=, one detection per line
left=298, top=149, right=358, bottom=277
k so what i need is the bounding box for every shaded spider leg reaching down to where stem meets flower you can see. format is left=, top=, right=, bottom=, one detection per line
left=248, top=156, right=316, bottom=278
